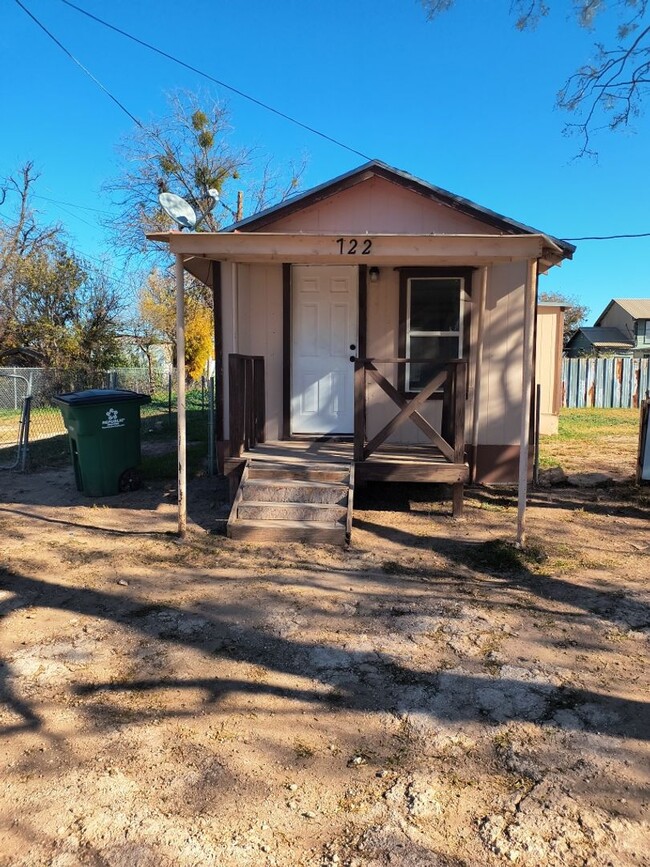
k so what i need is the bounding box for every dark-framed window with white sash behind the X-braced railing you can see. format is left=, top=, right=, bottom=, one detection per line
left=400, top=268, right=471, bottom=396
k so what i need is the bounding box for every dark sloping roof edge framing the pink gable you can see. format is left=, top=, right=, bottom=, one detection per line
left=223, top=160, right=575, bottom=259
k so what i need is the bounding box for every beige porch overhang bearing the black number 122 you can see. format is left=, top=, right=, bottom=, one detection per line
left=147, top=232, right=564, bottom=280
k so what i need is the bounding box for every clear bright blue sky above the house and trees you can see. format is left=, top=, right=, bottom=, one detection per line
left=0, top=0, right=650, bottom=323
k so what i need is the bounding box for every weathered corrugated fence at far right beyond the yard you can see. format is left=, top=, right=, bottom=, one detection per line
left=562, top=356, right=650, bottom=408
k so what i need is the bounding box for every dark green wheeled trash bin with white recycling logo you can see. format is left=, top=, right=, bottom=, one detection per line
left=53, top=388, right=151, bottom=497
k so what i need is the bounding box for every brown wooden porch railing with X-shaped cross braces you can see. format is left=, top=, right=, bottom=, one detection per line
left=354, top=358, right=467, bottom=464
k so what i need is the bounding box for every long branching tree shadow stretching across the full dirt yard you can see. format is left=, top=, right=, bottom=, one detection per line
left=0, top=570, right=650, bottom=740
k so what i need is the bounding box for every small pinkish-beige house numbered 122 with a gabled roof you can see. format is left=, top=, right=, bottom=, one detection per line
left=148, top=161, right=575, bottom=536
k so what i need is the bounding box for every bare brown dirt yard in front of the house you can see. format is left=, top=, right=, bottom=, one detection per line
left=0, top=448, right=650, bottom=867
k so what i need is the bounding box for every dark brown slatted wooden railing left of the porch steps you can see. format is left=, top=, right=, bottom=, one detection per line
left=228, top=354, right=266, bottom=457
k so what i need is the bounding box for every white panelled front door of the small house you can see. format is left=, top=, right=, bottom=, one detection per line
left=291, top=265, right=358, bottom=434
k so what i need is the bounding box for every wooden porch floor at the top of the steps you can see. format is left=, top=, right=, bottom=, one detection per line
left=225, top=437, right=469, bottom=485
